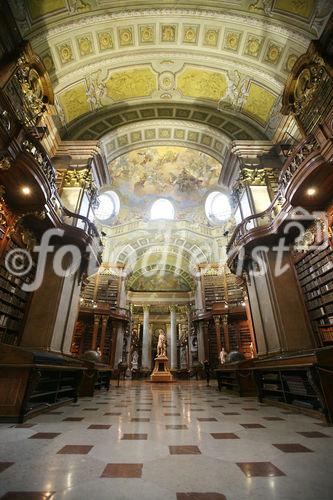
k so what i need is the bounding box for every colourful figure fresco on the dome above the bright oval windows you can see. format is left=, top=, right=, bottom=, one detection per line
left=109, top=146, right=221, bottom=211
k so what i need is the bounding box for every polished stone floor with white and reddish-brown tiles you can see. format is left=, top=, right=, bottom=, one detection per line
left=0, top=382, right=333, bottom=500
